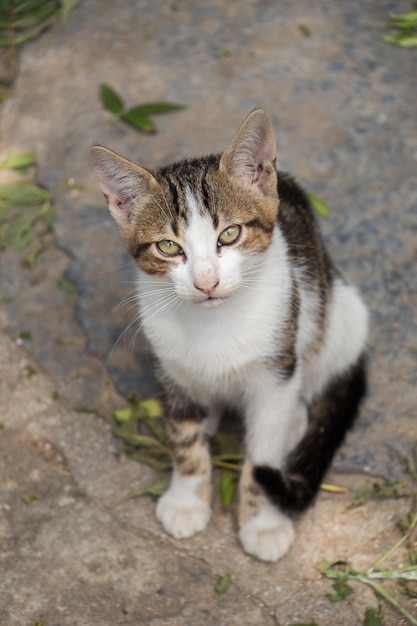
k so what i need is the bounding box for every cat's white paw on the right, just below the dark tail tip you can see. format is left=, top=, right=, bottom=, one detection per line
left=239, top=503, right=295, bottom=561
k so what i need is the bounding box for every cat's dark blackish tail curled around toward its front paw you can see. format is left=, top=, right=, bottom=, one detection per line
left=254, top=356, right=366, bottom=515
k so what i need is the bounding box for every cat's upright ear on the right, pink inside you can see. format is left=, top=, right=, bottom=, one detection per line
left=220, top=109, right=277, bottom=196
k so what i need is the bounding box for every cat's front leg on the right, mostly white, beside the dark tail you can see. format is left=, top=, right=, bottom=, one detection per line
left=239, top=373, right=300, bottom=561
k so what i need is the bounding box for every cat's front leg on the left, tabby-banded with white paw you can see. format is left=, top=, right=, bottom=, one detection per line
left=156, top=398, right=215, bottom=539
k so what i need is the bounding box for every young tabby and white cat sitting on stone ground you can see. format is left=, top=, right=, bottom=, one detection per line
left=92, top=109, right=368, bottom=561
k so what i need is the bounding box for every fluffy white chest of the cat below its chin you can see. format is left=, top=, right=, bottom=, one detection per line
left=140, top=282, right=286, bottom=396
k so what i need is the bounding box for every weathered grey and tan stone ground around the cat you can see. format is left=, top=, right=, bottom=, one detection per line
left=0, top=0, right=417, bottom=626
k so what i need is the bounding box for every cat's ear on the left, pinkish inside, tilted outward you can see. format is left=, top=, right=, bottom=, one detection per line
left=91, top=146, right=158, bottom=231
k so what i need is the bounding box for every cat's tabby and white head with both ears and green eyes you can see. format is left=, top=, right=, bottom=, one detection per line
left=92, top=109, right=278, bottom=306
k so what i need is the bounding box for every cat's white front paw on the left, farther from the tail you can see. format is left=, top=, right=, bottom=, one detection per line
left=156, top=490, right=211, bottom=539
